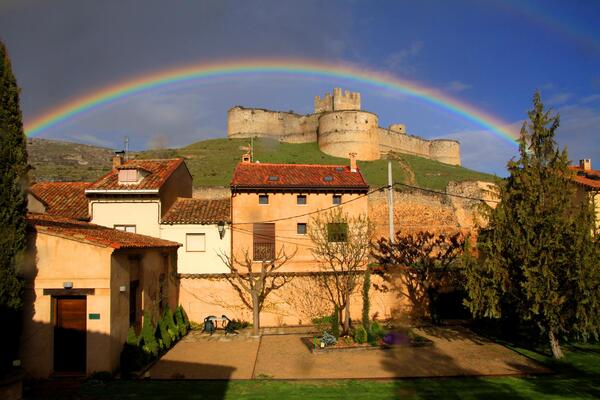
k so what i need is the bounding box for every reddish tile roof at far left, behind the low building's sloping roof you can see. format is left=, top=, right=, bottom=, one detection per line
left=29, top=182, right=92, bottom=219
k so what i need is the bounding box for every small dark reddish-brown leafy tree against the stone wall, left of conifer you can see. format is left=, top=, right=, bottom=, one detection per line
left=372, top=231, right=464, bottom=323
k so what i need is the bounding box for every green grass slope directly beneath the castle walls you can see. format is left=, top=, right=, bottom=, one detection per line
left=139, top=139, right=497, bottom=190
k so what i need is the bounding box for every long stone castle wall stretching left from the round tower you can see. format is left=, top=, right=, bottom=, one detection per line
left=227, top=107, right=318, bottom=143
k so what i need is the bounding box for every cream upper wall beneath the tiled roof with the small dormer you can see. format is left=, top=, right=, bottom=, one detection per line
left=90, top=199, right=160, bottom=237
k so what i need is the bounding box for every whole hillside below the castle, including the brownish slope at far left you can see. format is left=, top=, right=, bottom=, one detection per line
left=29, top=139, right=497, bottom=190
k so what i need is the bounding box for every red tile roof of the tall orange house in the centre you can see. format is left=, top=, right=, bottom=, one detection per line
left=231, top=162, right=369, bottom=190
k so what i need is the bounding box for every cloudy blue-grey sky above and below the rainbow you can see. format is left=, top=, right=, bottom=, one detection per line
left=0, top=0, right=600, bottom=176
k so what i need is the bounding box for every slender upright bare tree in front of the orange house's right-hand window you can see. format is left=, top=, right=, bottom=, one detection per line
left=308, top=208, right=372, bottom=334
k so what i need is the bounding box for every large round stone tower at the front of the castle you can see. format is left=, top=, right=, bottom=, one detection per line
left=317, top=111, right=380, bottom=161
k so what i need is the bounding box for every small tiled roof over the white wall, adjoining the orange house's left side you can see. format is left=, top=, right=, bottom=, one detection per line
left=162, top=197, right=231, bottom=224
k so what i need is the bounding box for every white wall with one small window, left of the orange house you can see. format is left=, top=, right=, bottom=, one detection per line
left=160, top=224, right=231, bottom=274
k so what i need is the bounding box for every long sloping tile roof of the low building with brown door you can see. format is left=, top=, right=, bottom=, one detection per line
left=27, top=213, right=181, bottom=249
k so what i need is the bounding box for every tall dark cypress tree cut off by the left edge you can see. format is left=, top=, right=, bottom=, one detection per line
left=0, top=42, right=28, bottom=314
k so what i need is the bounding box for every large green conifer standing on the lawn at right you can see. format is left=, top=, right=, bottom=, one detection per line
left=465, top=93, right=600, bottom=358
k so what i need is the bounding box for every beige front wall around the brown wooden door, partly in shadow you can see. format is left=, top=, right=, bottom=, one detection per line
left=21, top=233, right=115, bottom=378
